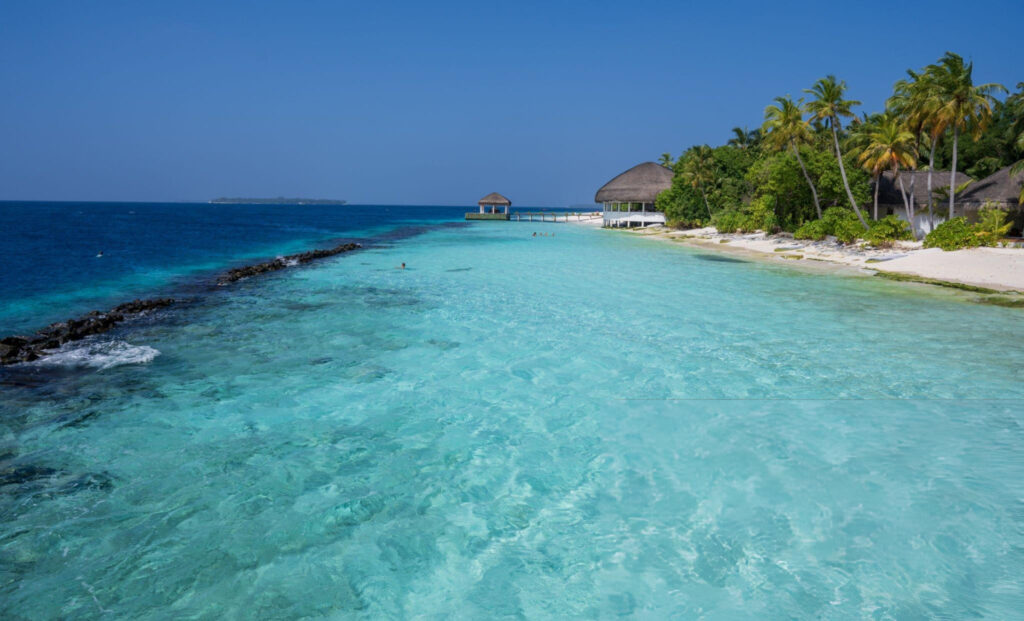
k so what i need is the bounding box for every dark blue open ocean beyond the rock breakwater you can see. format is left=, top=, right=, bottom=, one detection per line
left=0, top=202, right=467, bottom=335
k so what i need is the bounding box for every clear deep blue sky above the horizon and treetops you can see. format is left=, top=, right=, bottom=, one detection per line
left=0, top=0, right=1024, bottom=206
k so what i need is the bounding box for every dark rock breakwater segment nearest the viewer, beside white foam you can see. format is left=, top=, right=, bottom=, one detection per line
left=0, top=297, right=174, bottom=365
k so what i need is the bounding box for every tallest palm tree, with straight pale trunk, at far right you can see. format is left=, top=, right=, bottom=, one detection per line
left=925, top=51, right=1007, bottom=219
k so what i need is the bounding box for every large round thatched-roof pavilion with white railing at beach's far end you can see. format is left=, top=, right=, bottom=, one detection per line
left=594, top=162, right=673, bottom=226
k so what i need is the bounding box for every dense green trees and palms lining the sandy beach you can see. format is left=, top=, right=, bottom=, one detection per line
left=656, top=52, right=1024, bottom=240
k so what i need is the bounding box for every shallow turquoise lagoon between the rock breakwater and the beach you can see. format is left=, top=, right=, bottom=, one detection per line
left=0, top=223, right=1024, bottom=619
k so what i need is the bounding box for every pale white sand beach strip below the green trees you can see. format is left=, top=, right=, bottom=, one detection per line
left=577, top=226, right=1024, bottom=303
